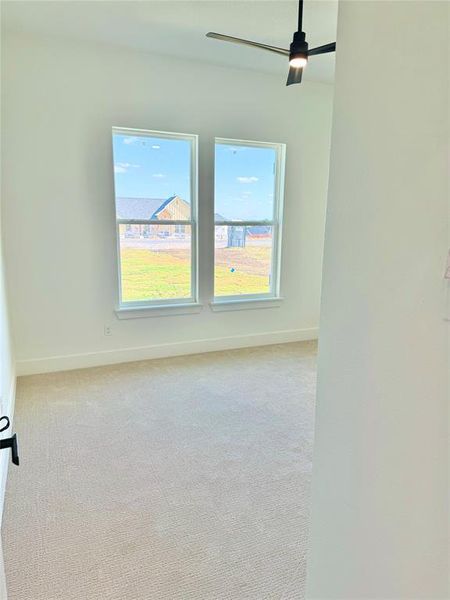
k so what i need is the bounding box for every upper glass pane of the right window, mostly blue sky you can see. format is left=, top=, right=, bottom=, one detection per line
left=214, top=143, right=276, bottom=221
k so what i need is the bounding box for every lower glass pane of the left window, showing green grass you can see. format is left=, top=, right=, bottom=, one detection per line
left=119, top=224, right=191, bottom=302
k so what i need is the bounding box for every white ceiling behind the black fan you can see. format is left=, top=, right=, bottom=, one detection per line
left=1, top=0, right=337, bottom=83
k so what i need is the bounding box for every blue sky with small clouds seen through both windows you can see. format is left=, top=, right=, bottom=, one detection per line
left=113, top=134, right=276, bottom=220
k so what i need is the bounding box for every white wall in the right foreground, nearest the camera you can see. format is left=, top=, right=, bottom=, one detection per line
left=307, top=1, right=450, bottom=600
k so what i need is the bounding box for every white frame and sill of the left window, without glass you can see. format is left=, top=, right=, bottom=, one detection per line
left=111, top=126, right=199, bottom=311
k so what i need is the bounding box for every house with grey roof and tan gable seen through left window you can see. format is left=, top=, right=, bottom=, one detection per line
left=116, top=196, right=191, bottom=238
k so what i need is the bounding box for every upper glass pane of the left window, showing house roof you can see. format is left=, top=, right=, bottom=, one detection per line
left=113, top=132, right=191, bottom=220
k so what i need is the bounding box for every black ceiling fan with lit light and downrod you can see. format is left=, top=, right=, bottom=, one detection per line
left=206, top=0, right=336, bottom=85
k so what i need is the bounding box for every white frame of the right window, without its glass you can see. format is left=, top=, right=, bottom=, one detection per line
left=211, top=137, right=286, bottom=307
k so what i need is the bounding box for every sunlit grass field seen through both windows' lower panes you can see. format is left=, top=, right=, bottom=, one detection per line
left=121, top=246, right=270, bottom=302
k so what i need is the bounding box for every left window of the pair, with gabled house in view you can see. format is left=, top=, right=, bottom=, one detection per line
left=113, top=128, right=197, bottom=308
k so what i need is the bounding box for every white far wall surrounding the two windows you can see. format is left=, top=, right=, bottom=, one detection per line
left=3, top=34, right=332, bottom=373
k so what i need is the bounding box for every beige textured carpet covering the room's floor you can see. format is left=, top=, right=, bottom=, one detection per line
left=3, top=342, right=316, bottom=600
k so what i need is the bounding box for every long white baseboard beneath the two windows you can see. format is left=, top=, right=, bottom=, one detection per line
left=16, top=327, right=318, bottom=375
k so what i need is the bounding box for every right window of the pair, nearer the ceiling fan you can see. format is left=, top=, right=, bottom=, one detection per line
left=214, top=138, right=285, bottom=302
